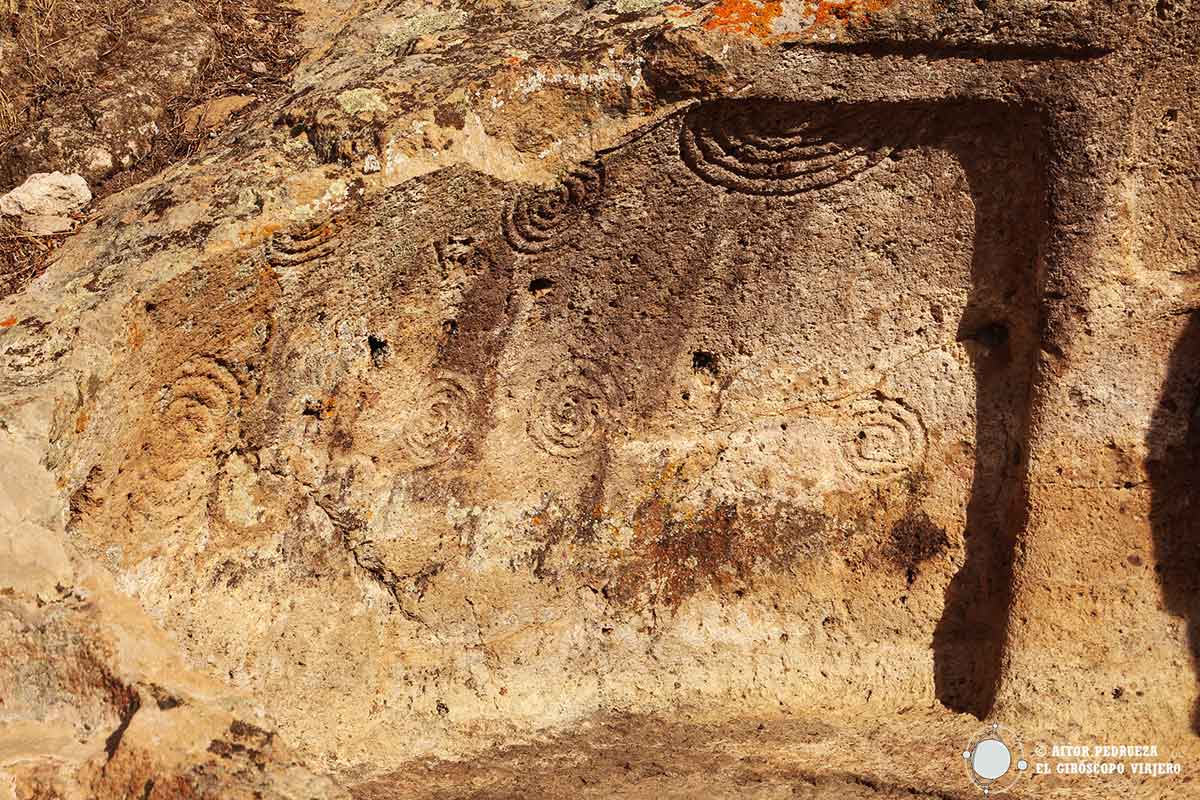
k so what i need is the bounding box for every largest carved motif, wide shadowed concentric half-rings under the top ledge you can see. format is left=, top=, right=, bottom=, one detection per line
left=680, top=101, right=892, bottom=196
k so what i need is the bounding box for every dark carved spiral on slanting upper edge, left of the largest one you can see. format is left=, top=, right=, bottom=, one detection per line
left=503, top=162, right=605, bottom=253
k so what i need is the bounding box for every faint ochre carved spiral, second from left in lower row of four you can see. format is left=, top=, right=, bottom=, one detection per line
left=401, top=373, right=475, bottom=467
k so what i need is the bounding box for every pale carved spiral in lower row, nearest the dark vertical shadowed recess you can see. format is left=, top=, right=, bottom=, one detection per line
left=844, top=397, right=925, bottom=477
